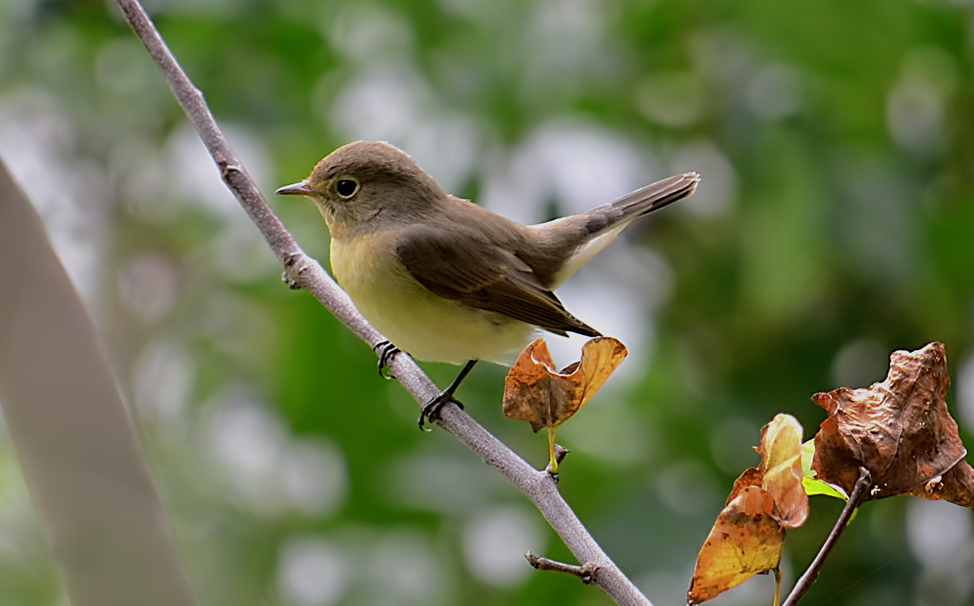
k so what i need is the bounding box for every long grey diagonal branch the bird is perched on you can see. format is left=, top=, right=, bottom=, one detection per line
left=115, top=0, right=652, bottom=606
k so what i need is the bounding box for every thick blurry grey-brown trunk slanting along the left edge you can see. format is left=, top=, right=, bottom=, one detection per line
left=0, top=162, right=195, bottom=606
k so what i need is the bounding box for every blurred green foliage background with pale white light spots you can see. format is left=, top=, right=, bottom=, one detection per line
left=0, top=0, right=974, bottom=606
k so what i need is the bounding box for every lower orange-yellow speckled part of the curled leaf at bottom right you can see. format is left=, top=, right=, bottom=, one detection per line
left=687, top=490, right=785, bottom=604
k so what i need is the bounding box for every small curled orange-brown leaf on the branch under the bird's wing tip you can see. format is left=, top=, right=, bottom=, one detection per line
left=504, top=337, right=628, bottom=431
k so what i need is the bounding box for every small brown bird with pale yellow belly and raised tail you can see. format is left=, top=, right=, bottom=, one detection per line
left=277, top=141, right=699, bottom=427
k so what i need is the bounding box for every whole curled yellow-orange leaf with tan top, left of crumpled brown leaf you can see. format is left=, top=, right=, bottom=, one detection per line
left=687, top=414, right=808, bottom=604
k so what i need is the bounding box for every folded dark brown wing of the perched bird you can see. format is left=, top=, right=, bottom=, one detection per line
left=396, top=226, right=599, bottom=337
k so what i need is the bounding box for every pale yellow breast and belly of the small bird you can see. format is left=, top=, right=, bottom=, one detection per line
left=331, top=234, right=536, bottom=364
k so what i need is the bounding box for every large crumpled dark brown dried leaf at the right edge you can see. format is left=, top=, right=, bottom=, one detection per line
left=812, top=343, right=967, bottom=500
